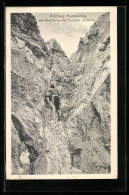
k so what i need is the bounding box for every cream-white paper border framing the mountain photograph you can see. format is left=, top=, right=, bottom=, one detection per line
left=6, top=7, right=118, bottom=180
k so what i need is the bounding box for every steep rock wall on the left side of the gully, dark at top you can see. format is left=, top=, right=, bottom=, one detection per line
left=11, top=14, right=51, bottom=174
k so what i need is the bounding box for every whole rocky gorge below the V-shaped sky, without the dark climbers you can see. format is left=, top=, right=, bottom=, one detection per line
left=11, top=13, right=111, bottom=175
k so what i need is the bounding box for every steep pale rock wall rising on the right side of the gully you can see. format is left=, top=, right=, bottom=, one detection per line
left=67, top=13, right=111, bottom=173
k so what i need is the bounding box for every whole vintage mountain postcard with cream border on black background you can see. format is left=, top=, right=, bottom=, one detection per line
left=5, top=7, right=118, bottom=180
